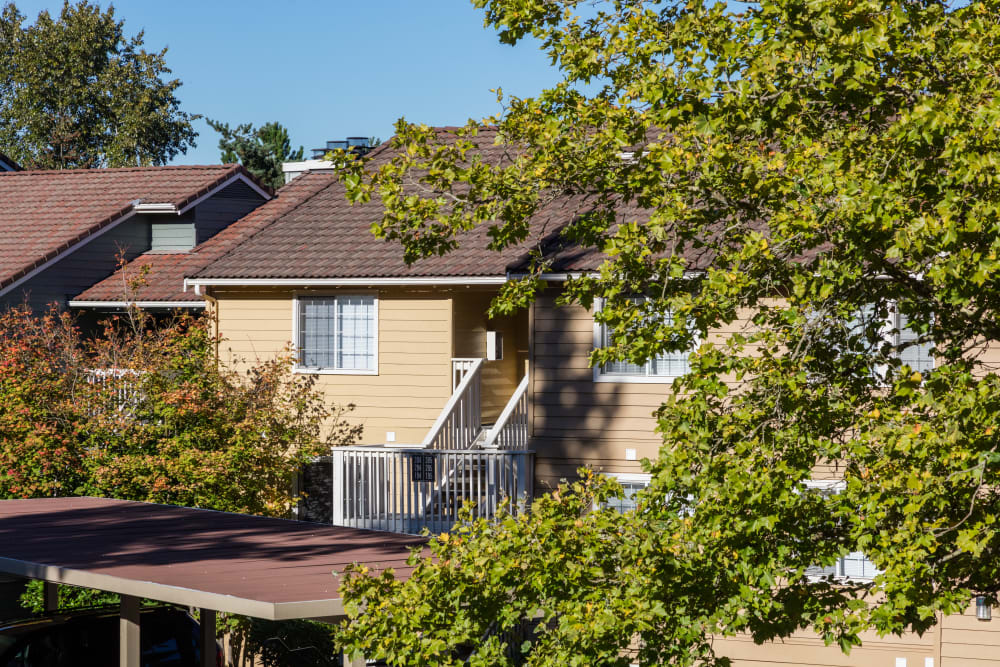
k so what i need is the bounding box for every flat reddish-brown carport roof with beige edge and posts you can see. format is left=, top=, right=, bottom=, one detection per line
left=0, top=498, right=424, bottom=667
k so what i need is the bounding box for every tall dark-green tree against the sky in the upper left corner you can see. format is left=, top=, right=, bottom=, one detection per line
left=0, top=0, right=197, bottom=169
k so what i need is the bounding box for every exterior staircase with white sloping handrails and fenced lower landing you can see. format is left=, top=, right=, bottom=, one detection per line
left=332, top=359, right=534, bottom=533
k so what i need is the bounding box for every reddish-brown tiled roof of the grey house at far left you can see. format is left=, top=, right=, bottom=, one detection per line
left=0, top=165, right=268, bottom=289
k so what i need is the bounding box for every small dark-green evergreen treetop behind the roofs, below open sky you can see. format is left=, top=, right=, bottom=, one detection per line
left=208, top=120, right=303, bottom=189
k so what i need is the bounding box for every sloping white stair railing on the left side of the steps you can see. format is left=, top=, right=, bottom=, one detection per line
left=421, top=359, right=483, bottom=449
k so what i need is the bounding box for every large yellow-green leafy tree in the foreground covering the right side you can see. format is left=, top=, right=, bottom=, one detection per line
left=342, top=0, right=1000, bottom=665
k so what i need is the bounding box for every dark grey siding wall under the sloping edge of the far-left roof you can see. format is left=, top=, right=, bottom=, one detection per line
left=0, top=216, right=150, bottom=311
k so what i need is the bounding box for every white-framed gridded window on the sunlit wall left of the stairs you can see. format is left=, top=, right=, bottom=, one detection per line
left=295, top=294, right=378, bottom=374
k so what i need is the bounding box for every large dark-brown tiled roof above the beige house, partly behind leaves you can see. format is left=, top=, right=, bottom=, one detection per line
left=193, top=128, right=710, bottom=281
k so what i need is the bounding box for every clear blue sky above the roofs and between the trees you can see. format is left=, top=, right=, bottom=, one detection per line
left=13, top=0, right=557, bottom=164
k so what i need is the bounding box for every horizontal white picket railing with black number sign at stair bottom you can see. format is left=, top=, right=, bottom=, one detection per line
left=332, top=447, right=534, bottom=533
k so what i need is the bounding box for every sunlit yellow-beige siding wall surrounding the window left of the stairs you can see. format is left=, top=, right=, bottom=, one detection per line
left=212, top=288, right=452, bottom=444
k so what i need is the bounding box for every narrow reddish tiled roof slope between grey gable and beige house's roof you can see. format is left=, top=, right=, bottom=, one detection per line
left=73, top=173, right=336, bottom=302
